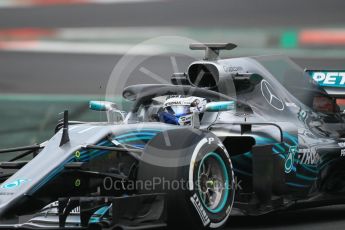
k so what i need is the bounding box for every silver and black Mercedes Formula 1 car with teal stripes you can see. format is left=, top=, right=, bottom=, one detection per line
left=0, top=43, right=345, bottom=229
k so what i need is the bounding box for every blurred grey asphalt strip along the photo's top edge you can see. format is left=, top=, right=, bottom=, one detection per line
left=0, top=0, right=345, bottom=28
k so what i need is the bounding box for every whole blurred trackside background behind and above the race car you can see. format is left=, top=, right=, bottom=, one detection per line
left=0, top=0, right=345, bottom=148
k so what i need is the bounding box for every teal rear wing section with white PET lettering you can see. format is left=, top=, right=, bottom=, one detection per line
left=306, top=70, right=345, bottom=98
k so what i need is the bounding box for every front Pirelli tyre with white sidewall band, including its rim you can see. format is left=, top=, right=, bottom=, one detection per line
left=137, top=128, right=235, bottom=229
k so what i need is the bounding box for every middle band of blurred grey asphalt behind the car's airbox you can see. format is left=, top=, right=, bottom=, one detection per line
left=0, top=52, right=344, bottom=95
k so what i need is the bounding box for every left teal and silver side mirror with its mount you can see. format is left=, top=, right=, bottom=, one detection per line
left=89, top=101, right=127, bottom=122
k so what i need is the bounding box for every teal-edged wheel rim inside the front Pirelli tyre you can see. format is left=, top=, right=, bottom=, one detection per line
left=198, top=152, right=229, bottom=213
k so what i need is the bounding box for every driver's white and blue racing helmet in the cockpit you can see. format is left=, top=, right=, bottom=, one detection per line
left=158, top=96, right=207, bottom=126
